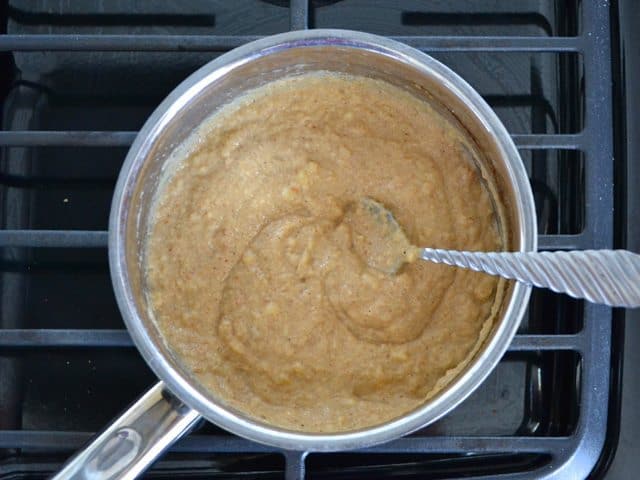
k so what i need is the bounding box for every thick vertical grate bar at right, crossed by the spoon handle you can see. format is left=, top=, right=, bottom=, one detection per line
left=548, top=0, right=615, bottom=479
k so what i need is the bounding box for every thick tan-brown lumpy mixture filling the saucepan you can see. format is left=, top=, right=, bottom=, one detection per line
left=146, top=74, right=504, bottom=432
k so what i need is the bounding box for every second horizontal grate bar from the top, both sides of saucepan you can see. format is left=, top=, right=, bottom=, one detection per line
left=0, top=130, right=583, bottom=150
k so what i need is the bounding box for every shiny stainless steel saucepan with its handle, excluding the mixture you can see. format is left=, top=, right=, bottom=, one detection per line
left=52, top=30, right=537, bottom=479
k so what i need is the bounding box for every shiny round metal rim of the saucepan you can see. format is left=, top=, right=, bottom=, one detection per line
left=109, top=29, right=537, bottom=451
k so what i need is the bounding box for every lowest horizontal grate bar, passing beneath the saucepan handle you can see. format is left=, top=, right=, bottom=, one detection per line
left=0, top=430, right=571, bottom=455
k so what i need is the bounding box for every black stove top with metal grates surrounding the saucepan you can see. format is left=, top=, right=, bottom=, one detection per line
left=0, top=0, right=638, bottom=478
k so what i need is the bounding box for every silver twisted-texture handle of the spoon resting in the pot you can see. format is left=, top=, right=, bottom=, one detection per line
left=421, top=248, right=640, bottom=307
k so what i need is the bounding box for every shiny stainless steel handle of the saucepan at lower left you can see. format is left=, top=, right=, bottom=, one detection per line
left=53, top=382, right=200, bottom=480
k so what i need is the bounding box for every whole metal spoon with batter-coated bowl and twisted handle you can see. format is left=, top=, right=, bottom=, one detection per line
left=358, top=197, right=640, bottom=307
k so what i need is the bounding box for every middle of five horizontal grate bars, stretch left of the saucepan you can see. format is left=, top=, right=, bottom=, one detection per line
left=0, top=230, right=108, bottom=248
